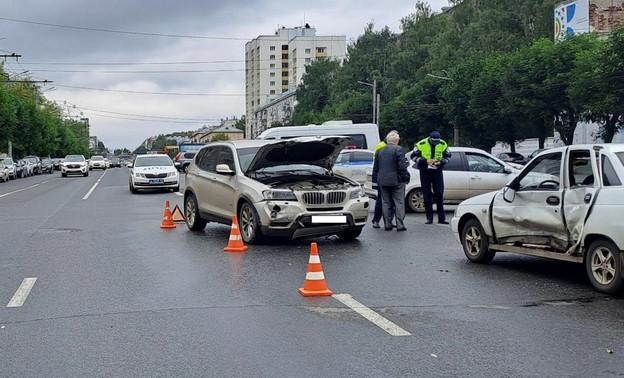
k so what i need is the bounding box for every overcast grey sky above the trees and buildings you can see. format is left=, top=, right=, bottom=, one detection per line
left=0, top=0, right=448, bottom=150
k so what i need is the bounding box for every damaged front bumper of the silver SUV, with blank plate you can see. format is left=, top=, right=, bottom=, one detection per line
left=254, top=196, right=369, bottom=239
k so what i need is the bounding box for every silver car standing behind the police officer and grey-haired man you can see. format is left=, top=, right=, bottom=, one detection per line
left=364, top=147, right=520, bottom=212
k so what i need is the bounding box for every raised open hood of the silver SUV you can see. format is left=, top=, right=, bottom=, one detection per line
left=247, top=136, right=351, bottom=172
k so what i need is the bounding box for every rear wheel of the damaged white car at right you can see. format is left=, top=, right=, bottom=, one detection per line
left=585, top=239, right=624, bottom=294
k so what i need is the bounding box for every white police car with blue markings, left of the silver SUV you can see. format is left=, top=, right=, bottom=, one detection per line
left=128, top=154, right=180, bottom=193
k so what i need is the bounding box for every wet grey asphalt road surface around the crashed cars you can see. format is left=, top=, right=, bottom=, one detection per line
left=0, top=168, right=624, bottom=377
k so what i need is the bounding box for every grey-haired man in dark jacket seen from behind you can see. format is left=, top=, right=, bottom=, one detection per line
left=373, top=132, right=410, bottom=231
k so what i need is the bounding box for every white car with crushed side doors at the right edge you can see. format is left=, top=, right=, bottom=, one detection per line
left=451, top=144, right=624, bottom=293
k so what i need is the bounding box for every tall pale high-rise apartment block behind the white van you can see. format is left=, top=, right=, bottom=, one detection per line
left=245, top=24, right=347, bottom=139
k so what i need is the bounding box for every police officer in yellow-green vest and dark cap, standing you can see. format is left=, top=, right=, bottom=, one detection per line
left=411, top=131, right=451, bottom=224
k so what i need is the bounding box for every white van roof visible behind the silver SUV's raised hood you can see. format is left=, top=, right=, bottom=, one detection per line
left=256, top=121, right=380, bottom=151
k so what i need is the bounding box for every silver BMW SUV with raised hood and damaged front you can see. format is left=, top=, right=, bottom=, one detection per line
left=184, top=137, right=369, bottom=244
